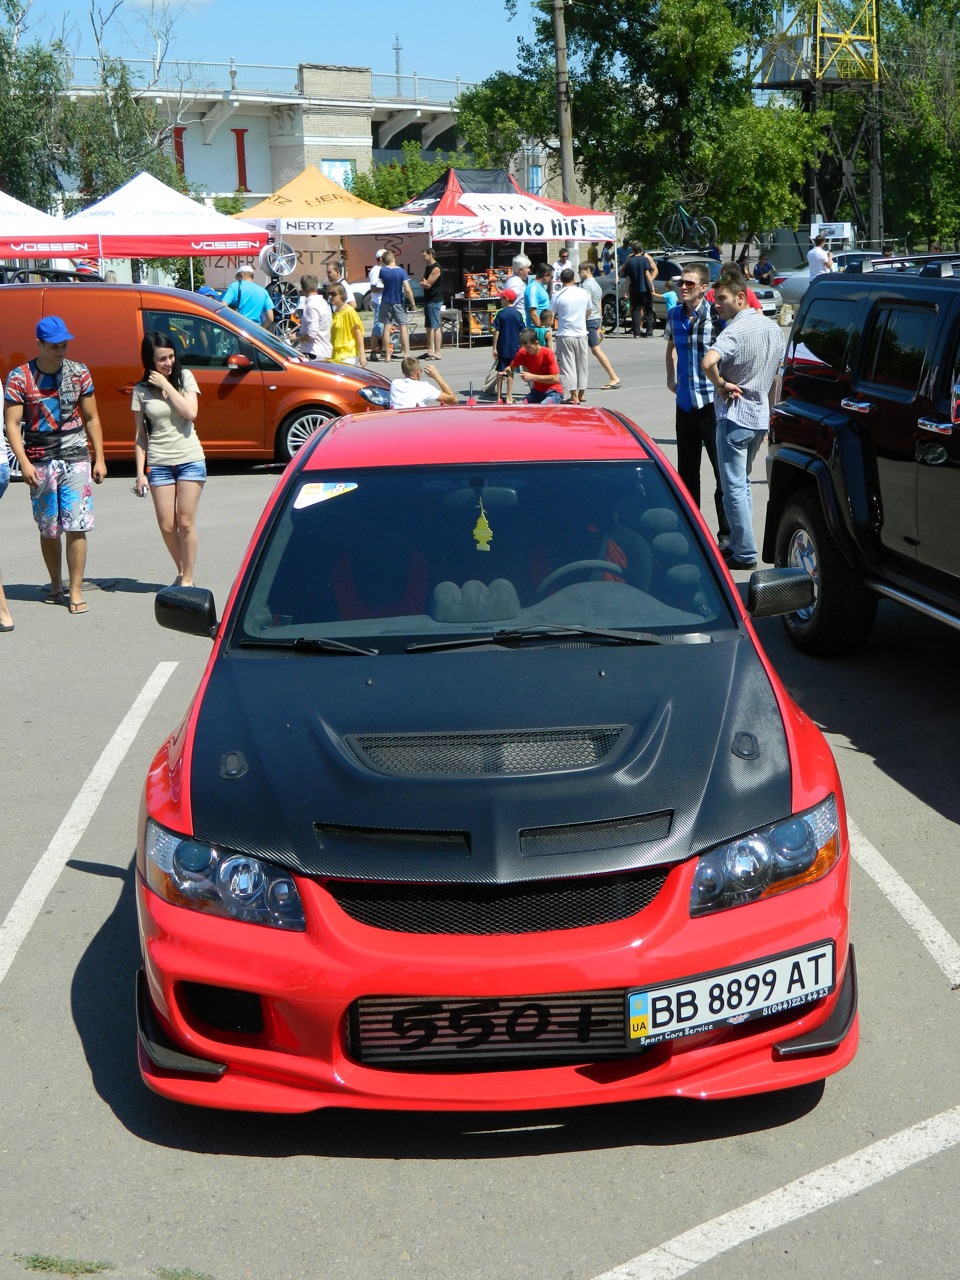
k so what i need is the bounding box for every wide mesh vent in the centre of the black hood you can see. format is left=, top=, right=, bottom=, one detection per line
left=347, top=724, right=626, bottom=774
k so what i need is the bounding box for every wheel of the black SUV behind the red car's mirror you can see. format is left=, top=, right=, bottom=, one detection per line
left=777, top=489, right=877, bottom=657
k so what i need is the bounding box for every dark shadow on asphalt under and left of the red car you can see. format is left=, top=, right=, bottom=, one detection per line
left=68, top=860, right=823, bottom=1160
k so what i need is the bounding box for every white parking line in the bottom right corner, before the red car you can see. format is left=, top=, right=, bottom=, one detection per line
left=595, top=1107, right=960, bottom=1280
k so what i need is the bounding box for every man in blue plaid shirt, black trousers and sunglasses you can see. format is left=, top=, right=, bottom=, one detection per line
left=664, top=262, right=730, bottom=547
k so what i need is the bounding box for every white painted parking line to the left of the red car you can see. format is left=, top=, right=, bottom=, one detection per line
left=0, top=662, right=177, bottom=982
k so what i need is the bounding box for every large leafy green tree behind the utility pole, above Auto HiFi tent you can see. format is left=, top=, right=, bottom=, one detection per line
left=458, top=0, right=812, bottom=237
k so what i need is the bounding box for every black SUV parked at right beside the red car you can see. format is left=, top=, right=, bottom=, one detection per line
left=763, top=260, right=960, bottom=654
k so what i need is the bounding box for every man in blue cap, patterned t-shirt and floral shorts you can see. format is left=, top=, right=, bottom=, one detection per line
left=4, top=316, right=106, bottom=617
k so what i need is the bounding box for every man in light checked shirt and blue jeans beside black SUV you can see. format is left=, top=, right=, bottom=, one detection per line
left=701, top=279, right=783, bottom=568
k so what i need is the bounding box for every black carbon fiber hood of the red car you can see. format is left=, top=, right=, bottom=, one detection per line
left=191, top=634, right=791, bottom=883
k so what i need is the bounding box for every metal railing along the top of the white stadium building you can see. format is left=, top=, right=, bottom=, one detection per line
left=70, top=58, right=472, bottom=104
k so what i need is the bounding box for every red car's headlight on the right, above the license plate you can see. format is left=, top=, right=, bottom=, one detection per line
left=690, top=796, right=840, bottom=915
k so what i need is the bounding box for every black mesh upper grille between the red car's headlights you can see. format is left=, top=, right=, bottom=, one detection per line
left=324, top=867, right=669, bottom=936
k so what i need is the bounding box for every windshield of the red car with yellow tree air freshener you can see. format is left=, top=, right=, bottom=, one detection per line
left=230, top=461, right=735, bottom=653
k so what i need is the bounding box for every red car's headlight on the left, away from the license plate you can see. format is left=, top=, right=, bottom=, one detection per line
left=143, top=818, right=306, bottom=931
